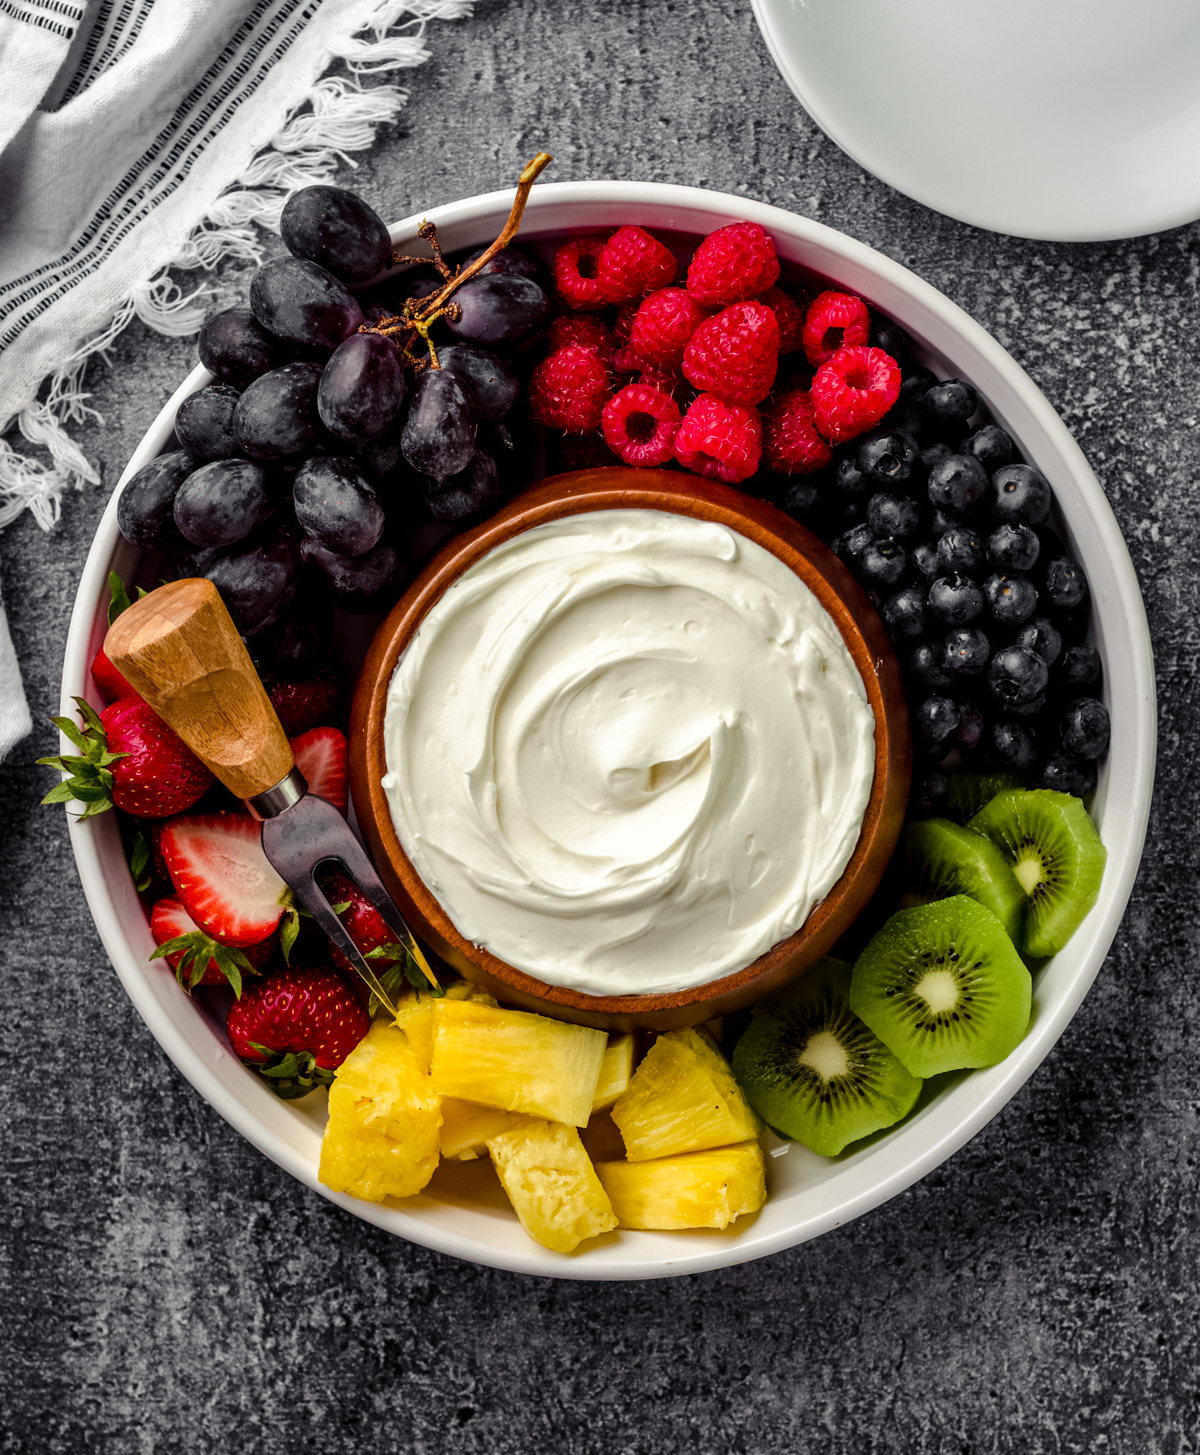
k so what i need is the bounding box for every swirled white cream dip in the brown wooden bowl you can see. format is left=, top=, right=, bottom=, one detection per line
left=383, top=509, right=874, bottom=995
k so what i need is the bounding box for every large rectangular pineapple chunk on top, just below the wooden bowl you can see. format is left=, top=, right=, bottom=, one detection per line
left=433, top=1000, right=608, bottom=1126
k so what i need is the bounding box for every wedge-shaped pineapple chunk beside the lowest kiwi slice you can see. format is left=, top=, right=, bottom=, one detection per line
left=612, top=1030, right=762, bottom=1163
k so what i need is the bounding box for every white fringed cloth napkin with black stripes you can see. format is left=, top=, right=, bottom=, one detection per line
left=0, top=0, right=471, bottom=758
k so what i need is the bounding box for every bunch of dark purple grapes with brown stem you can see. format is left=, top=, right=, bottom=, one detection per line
left=118, top=176, right=550, bottom=669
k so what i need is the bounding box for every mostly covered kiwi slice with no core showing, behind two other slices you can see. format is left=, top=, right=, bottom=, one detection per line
left=900, top=819, right=1027, bottom=944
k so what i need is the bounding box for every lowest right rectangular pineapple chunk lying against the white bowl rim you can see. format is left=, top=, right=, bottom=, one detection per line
left=596, top=1142, right=767, bottom=1228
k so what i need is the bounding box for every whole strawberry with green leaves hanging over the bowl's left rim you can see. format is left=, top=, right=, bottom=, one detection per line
left=38, top=697, right=212, bottom=818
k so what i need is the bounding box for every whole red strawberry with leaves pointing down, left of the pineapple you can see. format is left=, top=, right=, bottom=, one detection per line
left=225, top=969, right=371, bottom=1100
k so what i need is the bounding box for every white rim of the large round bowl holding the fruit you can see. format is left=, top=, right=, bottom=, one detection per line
left=61, top=180, right=1156, bottom=1280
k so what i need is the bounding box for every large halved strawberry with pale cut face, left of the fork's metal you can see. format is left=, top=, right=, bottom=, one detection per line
left=161, top=813, right=297, bottom=949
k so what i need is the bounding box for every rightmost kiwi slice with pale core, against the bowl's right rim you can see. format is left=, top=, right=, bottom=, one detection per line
left=967, top=789, right=1108, bottom=959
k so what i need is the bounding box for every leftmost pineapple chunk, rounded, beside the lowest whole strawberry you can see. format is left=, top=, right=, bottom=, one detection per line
left=317, top=1020, right=442, bottom=1202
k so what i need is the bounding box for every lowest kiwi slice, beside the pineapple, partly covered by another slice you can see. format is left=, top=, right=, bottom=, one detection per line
left=733, top=960, right=921, bottom=1157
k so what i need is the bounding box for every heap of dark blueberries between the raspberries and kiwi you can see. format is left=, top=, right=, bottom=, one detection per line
left=748, top=333, right=1108, bottom=810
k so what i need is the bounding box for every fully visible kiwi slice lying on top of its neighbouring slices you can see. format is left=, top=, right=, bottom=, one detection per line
left=849, top=895, right=1033, bottom=1077
